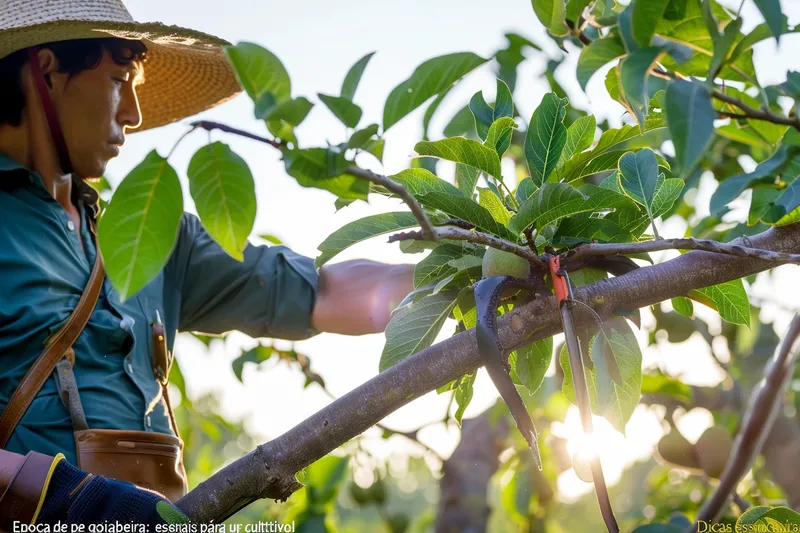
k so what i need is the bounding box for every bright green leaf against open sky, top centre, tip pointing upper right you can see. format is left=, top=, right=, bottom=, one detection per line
left=383, top=52, right=487, bottom=131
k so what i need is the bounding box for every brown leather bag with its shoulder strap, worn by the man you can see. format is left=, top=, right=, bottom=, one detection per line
left=0, top=228, right=187, bottom=501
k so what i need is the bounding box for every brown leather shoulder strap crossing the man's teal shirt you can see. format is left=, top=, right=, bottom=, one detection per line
left=0, top=245, right=106, bottom=448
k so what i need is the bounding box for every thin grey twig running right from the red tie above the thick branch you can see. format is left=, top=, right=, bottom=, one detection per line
left=564, top=238, right=800, bottom=264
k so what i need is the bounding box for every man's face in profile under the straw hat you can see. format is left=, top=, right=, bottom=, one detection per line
left=51, top=51, right=143, bottom=178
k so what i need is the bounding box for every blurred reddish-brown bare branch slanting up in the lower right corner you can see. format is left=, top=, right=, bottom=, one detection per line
left=697, top=315, right=800, bottom=522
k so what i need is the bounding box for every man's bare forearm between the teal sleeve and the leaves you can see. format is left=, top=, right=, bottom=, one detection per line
left=311, top=259, right=414, bottom=335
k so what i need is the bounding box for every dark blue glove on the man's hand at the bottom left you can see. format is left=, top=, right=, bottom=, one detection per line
left=36, top=460, right=189, bottom=531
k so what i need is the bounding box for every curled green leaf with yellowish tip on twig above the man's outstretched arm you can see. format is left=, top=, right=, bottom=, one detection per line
left=283, top=148, right=369, bottom=200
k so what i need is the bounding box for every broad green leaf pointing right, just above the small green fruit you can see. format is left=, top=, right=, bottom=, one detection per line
left=508, top=183, right=631, bottom=233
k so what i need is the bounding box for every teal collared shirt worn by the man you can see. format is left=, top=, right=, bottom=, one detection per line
left=0, top=154, right=318, bottom=464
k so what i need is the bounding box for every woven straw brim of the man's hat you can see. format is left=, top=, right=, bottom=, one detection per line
left=0, top=20, right=241, bottom=133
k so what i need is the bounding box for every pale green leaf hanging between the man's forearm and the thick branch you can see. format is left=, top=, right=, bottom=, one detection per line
left=379, top=291, right=457, bottom=372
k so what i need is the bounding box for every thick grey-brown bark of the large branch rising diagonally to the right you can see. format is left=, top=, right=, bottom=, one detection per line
left=177, top=224, right=800, bottom=522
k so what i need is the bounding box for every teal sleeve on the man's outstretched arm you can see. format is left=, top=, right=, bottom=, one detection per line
left=168, top=214, right=319, bottom=340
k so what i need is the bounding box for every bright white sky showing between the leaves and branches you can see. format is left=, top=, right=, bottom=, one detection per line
left=107, top=0, right=800, bottom=493
